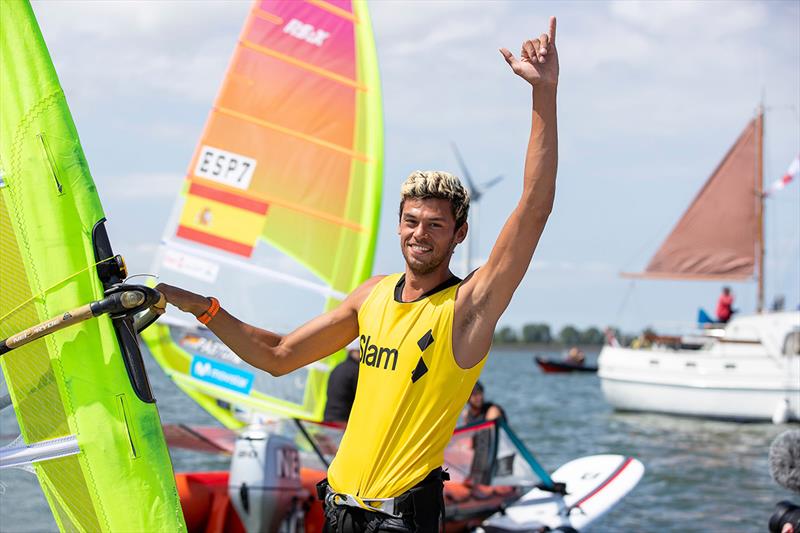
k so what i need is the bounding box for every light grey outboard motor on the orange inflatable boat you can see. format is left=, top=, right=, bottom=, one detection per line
left=228, top=426, right=309, bottom=533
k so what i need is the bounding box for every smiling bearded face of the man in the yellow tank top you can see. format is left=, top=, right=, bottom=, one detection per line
left=399, top=198, right=467, bottom=275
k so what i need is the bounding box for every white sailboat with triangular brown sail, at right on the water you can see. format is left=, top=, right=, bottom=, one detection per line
left=598, top=109, right=800, bottom=422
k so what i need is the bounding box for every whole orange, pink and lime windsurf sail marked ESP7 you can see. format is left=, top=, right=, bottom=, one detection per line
left=143, top=0, right=383, bottom=427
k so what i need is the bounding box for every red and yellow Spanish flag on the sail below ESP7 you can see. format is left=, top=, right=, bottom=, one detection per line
left=176, top=180, right=269, bottom=257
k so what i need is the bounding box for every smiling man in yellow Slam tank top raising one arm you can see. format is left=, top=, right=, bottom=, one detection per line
left=158, top=18, right=558, bottom=533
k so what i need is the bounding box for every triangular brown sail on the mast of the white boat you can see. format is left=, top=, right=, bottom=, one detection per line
left=627, top=114, right=764, bottom=280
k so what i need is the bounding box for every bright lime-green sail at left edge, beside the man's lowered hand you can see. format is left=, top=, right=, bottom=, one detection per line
left=0, top=0, right=185, bottom=532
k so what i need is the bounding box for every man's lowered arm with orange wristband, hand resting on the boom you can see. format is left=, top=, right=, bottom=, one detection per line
left=156, top=276, right=381, bottom=376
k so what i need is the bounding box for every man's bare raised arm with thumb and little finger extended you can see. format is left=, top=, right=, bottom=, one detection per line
left=453, top=17, right=558, bottom=368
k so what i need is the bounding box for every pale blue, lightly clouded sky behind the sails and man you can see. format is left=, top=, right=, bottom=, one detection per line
left=28, top=0, right=800, bottom=331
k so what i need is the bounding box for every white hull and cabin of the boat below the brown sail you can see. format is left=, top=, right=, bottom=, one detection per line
left=598, top=313, right=800, bottom=421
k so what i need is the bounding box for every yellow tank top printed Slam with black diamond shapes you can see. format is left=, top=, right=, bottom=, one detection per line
left=328, top=274, right=486, bottom=498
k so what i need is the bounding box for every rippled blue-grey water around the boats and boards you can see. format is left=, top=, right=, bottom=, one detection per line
left=0, top=350, right=800, bottom=533
